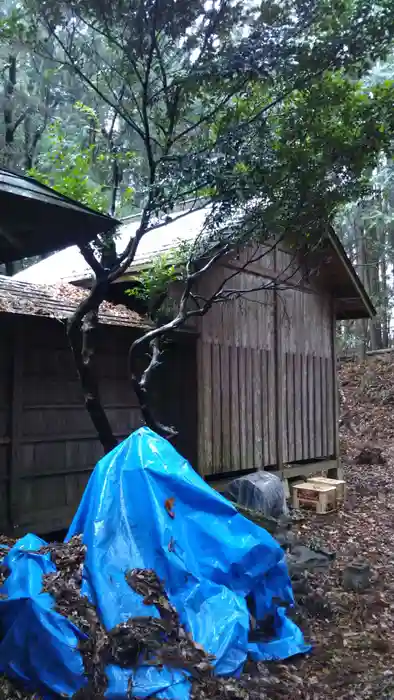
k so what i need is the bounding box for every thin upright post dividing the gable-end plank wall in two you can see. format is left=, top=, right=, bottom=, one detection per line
left=274, top=247, right=284, bottom=477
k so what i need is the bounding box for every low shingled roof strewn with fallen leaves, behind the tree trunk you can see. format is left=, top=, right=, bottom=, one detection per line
left=0, top=275, right=149, bottom=328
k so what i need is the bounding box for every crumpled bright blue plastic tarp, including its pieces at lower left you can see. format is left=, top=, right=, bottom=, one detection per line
left=0, top=428, right=309, bottom=700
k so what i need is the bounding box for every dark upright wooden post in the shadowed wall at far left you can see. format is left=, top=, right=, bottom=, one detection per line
left=9, top=318, right=24, bottom=527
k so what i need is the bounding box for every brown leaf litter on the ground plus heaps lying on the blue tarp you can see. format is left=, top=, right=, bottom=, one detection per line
left=0, top=358, right=394, bottom=700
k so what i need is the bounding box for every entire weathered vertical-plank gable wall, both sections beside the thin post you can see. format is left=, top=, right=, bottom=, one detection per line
left=197, top=243, right=335, bottom=475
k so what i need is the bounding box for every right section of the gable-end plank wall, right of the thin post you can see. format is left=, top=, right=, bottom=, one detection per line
left=279, top=289, right=335, bottom=463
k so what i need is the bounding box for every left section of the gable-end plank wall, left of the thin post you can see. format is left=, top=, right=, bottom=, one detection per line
left=197, top=268, right=276, bottom=475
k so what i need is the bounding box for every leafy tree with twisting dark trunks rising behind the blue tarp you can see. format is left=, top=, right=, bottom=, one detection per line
left=3, top=0, right=394, bottom=450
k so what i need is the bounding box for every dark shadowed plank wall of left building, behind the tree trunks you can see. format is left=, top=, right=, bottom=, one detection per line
left=0, top=317, right=196, bottom=532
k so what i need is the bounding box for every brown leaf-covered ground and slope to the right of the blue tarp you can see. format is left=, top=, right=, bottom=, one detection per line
left=0, top=355, right=394, bottom=700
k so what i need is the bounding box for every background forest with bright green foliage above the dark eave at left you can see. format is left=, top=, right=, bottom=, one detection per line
left=0, top=22, right=142, bottom=275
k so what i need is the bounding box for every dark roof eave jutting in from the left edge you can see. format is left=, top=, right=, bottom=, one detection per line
left=0, top=168, right=119, bottom=263
